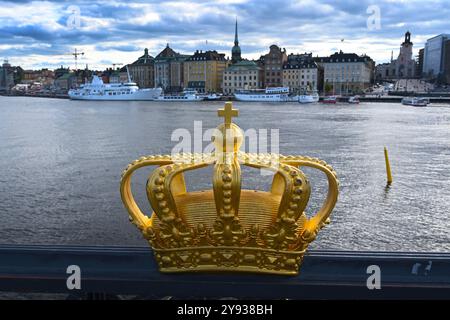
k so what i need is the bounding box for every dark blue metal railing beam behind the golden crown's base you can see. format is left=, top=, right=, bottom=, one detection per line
left=0, top=245, right=450, bottom=299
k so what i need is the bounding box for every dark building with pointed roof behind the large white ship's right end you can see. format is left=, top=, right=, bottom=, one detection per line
left=128, top=48, right=155, bottom=88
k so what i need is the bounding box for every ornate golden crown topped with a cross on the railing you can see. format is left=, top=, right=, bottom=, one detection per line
left=120, top=102, right=339, bottom=275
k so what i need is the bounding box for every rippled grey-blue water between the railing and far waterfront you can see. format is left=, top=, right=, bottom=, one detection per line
left=0, top=97, right=450, bottom=251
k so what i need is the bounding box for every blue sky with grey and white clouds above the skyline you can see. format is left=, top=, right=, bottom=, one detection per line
left=0, top=0, right=450, bottom=69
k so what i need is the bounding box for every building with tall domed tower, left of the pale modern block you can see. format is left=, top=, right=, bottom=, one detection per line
left=375, top=31, right=417, bottom=81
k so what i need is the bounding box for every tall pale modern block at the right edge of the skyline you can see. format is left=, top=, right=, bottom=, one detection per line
left=423, top=34, right=450, bottom=83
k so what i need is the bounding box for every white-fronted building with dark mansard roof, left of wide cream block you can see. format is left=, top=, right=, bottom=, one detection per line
left=283, top=53, right=323, bottom=93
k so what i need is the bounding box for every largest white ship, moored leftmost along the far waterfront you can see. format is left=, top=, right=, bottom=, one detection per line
left=68, top=69, right=162, bottom=101
